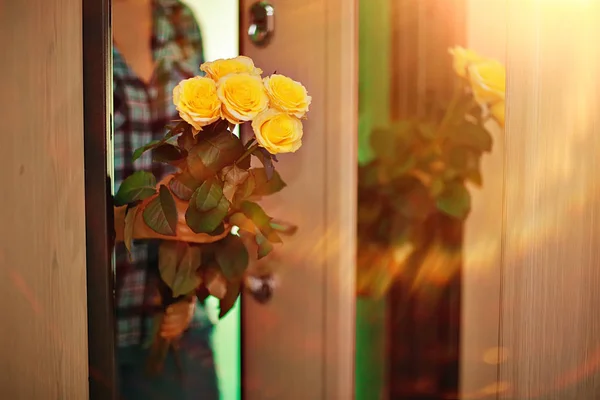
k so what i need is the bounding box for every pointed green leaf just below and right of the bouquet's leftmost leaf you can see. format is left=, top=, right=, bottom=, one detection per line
left=142, top=185, right=177, bottom=236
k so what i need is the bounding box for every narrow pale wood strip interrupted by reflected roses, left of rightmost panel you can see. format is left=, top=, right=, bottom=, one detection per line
left=460, top=0, right=507, bottom=399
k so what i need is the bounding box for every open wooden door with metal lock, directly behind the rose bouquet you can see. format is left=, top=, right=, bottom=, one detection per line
left=240, top=0, right=357, bottom=400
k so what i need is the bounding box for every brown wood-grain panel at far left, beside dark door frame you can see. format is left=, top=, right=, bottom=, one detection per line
left=0, top=0, right=88, bottom=400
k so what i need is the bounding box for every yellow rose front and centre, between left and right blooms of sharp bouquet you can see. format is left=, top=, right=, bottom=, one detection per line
left=217, top=74, right=269, bottom=124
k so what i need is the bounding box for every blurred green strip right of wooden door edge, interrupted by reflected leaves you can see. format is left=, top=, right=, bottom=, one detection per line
left=356, top=0, right=394, bottom=400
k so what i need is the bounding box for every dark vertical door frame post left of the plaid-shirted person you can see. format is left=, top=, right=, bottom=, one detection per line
left=82, top=0, right=117, bottom=400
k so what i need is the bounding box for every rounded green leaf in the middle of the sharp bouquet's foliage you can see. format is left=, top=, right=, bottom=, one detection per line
left=185, top=187, right=230, bottom=233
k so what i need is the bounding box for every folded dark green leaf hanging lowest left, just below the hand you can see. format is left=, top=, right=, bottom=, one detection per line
left=158, top=240, right=201, bottom=297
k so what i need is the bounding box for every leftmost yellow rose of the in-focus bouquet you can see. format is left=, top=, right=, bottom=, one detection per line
left=173, top=76, right=221, bottom=131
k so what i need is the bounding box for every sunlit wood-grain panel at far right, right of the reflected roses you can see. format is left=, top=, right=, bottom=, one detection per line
left=498, top=0, right=600, bottom=400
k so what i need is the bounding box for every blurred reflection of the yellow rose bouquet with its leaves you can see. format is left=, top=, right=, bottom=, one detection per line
left=357, top=47, right=506, bottom=296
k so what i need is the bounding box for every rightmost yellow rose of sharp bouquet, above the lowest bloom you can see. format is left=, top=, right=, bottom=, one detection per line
left=263, top=74, right=312, bottom=118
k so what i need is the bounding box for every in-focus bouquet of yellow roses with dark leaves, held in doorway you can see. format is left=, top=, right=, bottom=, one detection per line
left=114, top=56, right=311, bottom=372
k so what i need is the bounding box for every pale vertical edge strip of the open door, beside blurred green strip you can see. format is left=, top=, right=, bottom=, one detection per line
left=323, top=0, right=358, bottom=399
